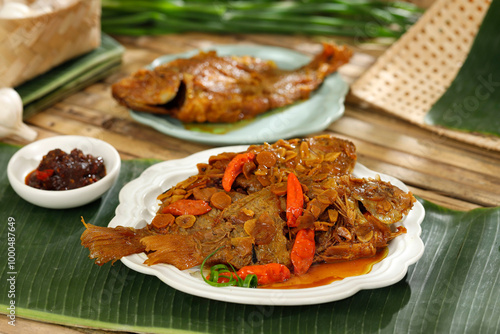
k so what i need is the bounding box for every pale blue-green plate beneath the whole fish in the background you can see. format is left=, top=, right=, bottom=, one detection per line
left=130, top=45, right=349, bottom=145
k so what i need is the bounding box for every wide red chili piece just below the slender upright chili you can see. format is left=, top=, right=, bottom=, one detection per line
left=290, top=229, right=316, bottom=276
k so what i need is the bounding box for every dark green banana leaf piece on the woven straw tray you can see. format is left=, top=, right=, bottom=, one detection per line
left=425, top=0, right=500, bottom=136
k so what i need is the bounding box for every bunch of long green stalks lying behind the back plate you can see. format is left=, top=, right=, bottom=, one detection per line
left=101, top=0, right=422, bottom=38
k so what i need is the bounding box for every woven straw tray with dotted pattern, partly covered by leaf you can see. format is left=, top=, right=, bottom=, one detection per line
left=351, top=0, right=500, bottom=151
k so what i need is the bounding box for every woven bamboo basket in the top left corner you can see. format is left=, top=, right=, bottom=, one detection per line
left=0, top=0, right=101, bottom=87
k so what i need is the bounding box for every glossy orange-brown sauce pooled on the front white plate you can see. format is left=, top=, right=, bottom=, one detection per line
left=259, top=247, right=389, bottom=289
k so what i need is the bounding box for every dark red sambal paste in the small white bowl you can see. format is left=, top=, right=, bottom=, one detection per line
left=25, top=148, right=106, bottom=190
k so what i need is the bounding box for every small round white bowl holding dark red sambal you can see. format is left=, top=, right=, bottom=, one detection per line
left=7, top=136, right=121, bottom=209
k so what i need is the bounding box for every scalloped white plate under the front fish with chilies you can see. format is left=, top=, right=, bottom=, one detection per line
left=109, top=146, right=425, bottom=305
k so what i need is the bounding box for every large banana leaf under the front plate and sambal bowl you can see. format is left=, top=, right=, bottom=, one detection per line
left=0, top=144, right=500, bottom=333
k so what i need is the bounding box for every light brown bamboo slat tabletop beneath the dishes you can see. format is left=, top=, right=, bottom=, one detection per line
left=0, top=34, right=500, bottom=334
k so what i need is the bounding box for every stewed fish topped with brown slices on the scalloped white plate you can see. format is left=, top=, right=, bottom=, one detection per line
left=81, top=135, right=415, bottom=276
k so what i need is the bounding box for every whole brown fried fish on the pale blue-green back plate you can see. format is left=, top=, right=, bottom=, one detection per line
left=112, top=43, right=352, bottom=123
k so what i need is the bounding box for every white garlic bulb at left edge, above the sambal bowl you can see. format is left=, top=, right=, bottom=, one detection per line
left=0, top=88, right=38, bottom=141
